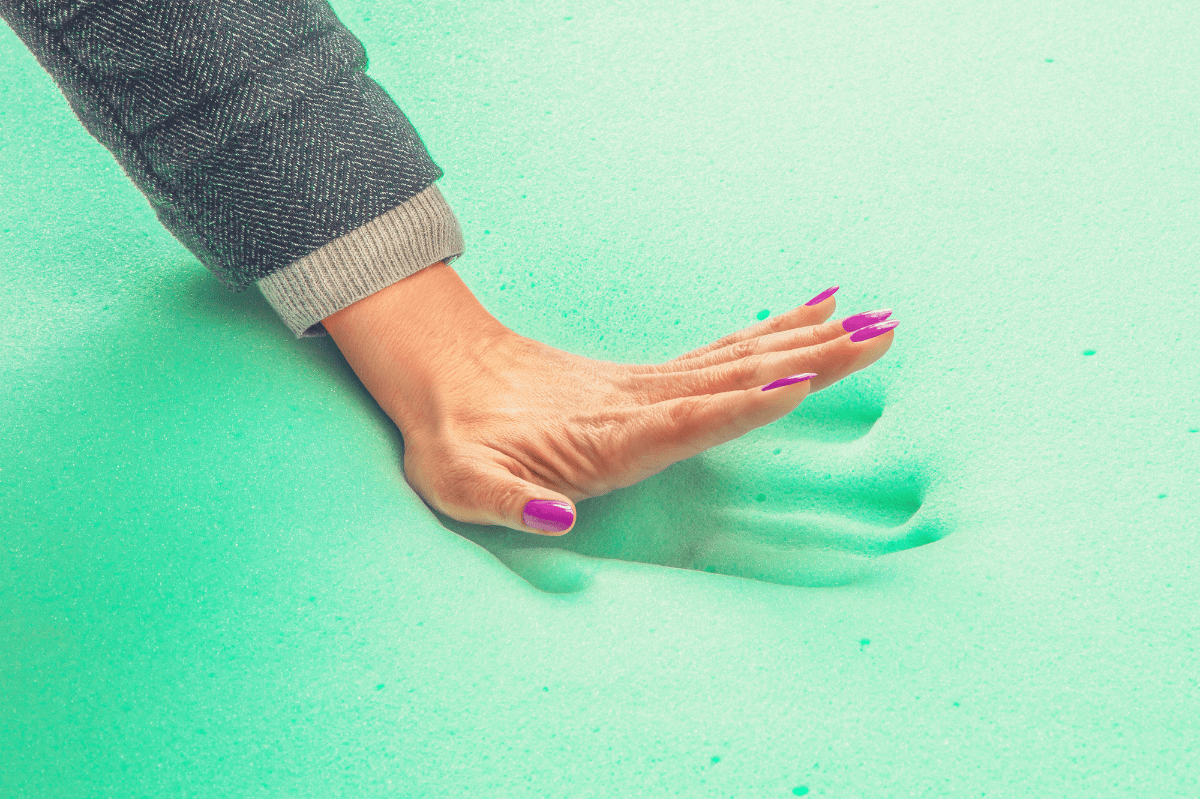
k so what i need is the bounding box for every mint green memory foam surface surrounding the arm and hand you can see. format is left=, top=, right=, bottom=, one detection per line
left=0, top=0, right=1200, bottom=798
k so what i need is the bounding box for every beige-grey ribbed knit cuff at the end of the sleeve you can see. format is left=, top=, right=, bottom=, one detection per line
left=256, top=184, right=464, bottom=338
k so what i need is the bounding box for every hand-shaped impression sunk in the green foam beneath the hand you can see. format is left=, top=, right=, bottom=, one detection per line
left=439, top=376, right=948, bottom=593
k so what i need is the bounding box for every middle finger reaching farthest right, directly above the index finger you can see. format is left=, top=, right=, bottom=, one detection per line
left=628, top=322, right=898, bottom=403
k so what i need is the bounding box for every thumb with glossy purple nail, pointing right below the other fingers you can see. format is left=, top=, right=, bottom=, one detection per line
left=438, top=453, right=576, bottom=535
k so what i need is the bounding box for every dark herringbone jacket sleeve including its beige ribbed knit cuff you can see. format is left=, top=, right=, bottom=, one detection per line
left=0, top=0, right=463, bottom=337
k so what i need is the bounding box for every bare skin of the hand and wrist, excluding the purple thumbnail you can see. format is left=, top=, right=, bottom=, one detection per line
left=323, top=262, right=895, bottom=535
